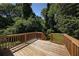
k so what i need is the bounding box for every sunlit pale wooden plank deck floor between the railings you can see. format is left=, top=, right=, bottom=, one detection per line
left=13, top=40, right=69, bottom=56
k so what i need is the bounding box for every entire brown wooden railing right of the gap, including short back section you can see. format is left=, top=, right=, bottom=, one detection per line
left=50, top=33, right=79, bottom=56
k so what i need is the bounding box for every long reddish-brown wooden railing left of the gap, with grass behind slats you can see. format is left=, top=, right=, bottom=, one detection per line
left=0, top=32, right=45, bottom=48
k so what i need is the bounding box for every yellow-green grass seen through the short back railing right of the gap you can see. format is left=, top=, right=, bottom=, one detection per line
left=50, top=33, right=64, bottom=44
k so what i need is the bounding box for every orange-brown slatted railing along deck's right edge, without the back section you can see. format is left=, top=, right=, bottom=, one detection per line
left=63, top=34, right=79, bottom=56
